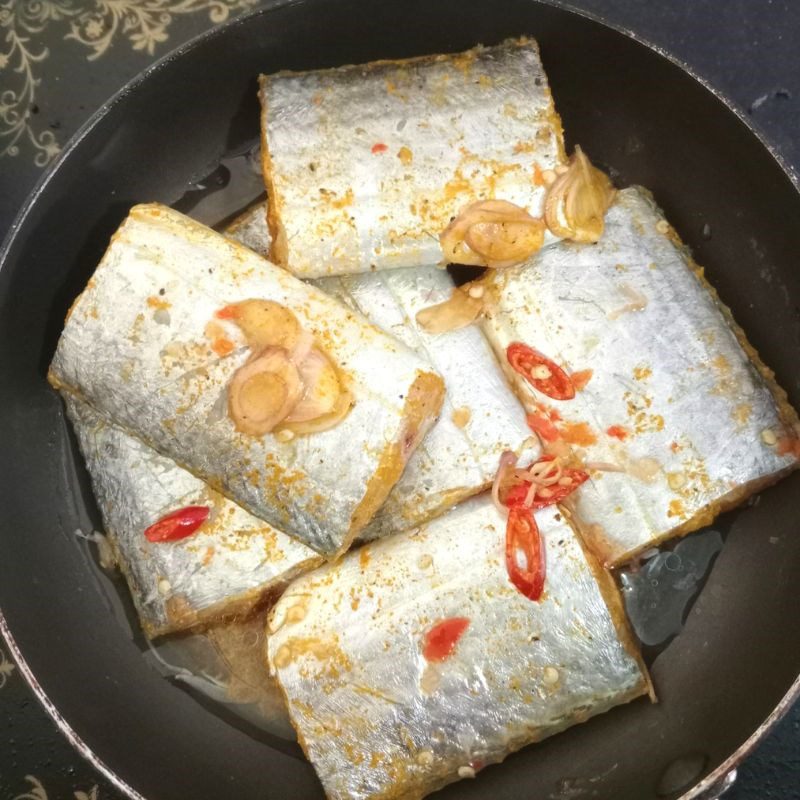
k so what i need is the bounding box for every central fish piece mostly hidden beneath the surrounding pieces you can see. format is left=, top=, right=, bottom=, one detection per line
left=225, top=204, right=541, bottom=541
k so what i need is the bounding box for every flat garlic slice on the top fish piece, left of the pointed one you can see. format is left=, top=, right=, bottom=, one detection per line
left=439, top=200, right=545, bottom=269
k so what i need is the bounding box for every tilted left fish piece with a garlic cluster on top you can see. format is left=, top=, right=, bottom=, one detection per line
left=50, top=205, right=443, bottom=556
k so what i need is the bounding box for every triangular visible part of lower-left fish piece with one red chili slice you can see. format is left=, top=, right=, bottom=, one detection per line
left=64, top=394, right=322, bottom=638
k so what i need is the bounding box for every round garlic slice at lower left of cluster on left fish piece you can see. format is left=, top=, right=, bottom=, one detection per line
left=228, top=347, right=303, bottom=436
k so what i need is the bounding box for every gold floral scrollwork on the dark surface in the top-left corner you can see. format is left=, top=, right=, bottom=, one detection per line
left=0, top=0, right=258, bottom=167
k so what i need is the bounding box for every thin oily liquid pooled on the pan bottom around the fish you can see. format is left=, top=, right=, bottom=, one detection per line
left=65, top=140, right=731, bottom=744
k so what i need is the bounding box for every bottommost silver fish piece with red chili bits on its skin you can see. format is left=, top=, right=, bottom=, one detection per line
left=267, top=495, right=650, bottom=800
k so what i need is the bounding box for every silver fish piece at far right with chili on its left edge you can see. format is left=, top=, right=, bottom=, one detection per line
left=483, top=188, right=798, bottom=565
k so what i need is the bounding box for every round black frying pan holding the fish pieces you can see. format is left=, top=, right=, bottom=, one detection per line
left=0, top=0, right=800, bottom=800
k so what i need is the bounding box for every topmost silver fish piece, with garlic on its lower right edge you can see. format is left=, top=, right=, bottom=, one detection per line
left=260, top=39, right=564, bottom=278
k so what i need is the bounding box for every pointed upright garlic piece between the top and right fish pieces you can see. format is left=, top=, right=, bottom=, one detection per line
left=544, top=145, right=615, bottom=243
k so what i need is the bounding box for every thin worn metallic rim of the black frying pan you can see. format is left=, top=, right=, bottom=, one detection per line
left=0, top=0, right=800, bottom=800
